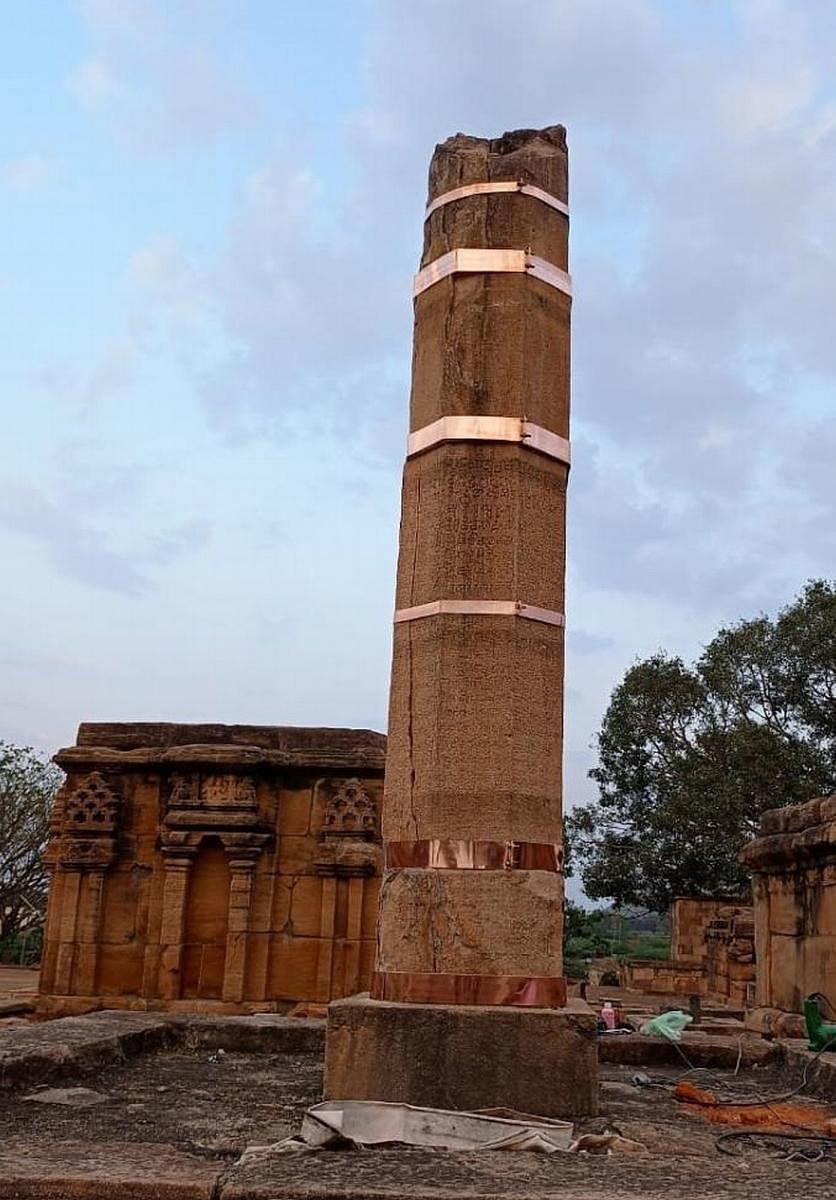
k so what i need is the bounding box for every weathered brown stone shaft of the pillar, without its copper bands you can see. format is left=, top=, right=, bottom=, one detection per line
left=377, top=126, right=570, bottom=993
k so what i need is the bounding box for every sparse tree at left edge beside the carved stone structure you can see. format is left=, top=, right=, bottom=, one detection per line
left=0, top=742, right=64, bottom=944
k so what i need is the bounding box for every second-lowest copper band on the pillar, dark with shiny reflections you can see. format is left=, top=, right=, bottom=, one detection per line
left=384, top=838, right=564, bottom=871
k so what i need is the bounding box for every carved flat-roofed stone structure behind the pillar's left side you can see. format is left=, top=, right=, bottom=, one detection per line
left=38, top=724, right=386, bottom=1013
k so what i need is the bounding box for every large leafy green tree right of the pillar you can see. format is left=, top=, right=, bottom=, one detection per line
left=566, top=581, right=836, bottom=911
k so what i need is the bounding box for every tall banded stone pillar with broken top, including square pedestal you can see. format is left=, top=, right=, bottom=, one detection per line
left=326, top=126, right=596, bottom=1115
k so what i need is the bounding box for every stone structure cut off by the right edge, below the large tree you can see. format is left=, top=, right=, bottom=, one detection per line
left=740, top=796, right=836, bottom=1032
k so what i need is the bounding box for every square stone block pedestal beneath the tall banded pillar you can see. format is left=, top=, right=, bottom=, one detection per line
left=325, top=995, right=599, bottom=1117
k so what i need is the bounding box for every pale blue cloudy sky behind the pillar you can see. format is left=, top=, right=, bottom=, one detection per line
left=0, top=0, right=836, bottom=835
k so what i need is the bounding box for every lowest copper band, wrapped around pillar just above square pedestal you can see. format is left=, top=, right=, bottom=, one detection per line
left=369, top=971, right=566, bottom=1008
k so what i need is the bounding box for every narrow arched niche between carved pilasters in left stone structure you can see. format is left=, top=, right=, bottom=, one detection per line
left=180, top=838, right=229, bottom=1000
